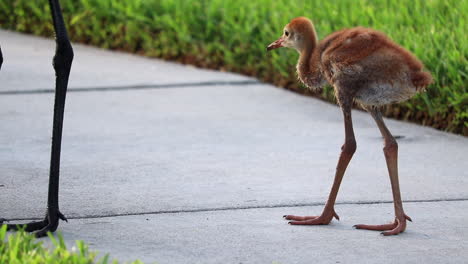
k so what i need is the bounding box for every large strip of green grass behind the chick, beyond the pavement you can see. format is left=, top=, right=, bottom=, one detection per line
left=0, top=0, right=468, bottom=135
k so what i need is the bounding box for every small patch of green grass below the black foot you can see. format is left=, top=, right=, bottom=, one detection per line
left=0, top=225, right=142, bottom=264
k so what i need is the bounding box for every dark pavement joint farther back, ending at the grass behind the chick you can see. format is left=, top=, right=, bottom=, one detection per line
left=0, top=80, right=262, bottom=95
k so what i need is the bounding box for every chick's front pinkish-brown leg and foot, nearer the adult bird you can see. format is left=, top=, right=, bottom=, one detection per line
left=283, top=103, right=356, bottom=225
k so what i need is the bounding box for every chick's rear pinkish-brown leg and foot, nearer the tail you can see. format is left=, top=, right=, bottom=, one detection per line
left=354, top=107, right=411, bottom=236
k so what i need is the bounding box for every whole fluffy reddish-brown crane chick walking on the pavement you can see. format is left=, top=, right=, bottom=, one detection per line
left=267, top=17, right=432, bottom=235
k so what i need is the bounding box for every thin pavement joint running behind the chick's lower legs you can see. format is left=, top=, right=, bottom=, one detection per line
left=8, top=198, right=468, bottom=221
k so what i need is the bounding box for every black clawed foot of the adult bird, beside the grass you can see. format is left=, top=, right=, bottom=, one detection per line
left=0, top=209, right=68, bottom=237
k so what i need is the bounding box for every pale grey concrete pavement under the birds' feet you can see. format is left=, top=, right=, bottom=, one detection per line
left=0, top=30, right=468, bottom=263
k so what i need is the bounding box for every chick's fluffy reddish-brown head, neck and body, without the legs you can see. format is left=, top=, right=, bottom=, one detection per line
left=269, top=17, right=432, bottom=105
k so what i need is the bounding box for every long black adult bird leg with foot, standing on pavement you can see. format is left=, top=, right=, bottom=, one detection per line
left=0, top=0, right=73, bottom=237
